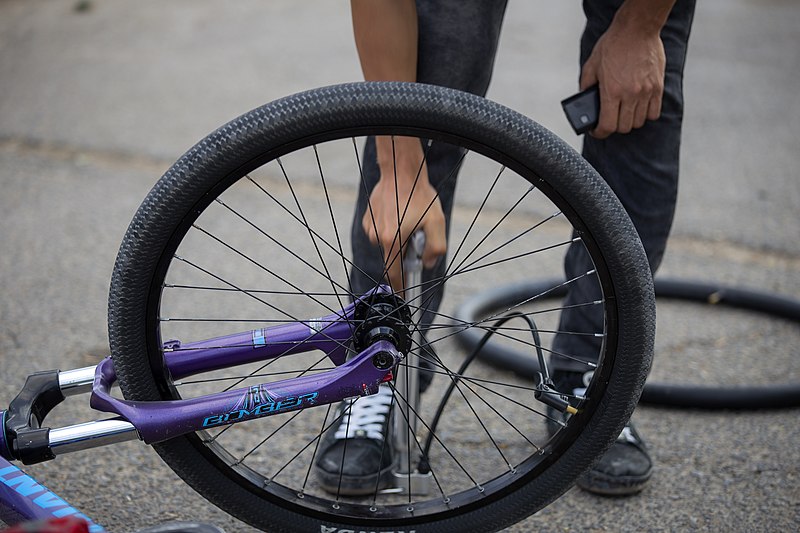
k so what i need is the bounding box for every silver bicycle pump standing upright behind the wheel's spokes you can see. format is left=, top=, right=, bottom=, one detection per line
left=393, top=230, right=430, bottom=495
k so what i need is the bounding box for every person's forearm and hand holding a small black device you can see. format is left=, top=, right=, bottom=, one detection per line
left=581, top=0, right=676, bottom=139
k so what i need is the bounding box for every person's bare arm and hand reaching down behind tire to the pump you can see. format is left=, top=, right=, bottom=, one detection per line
left=351, top=0, right=447, bottom=291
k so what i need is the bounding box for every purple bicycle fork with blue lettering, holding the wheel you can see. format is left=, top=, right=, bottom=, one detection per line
left=0, top=288, right=405, bottom=464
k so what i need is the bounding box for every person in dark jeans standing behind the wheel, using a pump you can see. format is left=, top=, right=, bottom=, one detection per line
left=315, top=0, right=695, bottom=495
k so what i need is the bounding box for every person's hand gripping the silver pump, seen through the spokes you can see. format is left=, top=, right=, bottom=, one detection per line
left=361, top=137, right=447, bottom=292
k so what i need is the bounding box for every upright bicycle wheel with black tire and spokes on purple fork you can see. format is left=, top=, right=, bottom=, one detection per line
left=109, top=83, right=654, bottom=532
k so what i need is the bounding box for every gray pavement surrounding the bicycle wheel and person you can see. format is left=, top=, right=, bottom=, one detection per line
left=0, top=0, right=800, bottom=531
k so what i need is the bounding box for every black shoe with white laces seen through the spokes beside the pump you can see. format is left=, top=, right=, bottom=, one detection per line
left=314, top=385, right=394, bottom=496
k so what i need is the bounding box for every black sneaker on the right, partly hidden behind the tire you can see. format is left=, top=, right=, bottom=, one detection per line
left=548, top=371, right=653, bottom=496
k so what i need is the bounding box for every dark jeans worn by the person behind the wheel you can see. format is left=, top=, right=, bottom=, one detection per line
left=351, top=0, right=695, bottom=378
